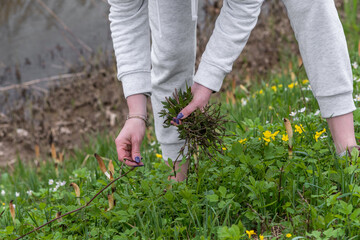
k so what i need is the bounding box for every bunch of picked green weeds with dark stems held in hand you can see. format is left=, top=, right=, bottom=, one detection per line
left=159, top=87, right=228, bottom=167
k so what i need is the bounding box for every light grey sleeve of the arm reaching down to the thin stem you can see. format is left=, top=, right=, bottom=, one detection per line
left=108, top=0, right=151, bottom=98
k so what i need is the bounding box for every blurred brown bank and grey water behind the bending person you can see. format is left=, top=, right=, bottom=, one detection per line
left=0, top=0, right=360, bottom=165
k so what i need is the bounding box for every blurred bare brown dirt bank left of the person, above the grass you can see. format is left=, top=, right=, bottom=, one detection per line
left=0, top=71, right=127, bottom=166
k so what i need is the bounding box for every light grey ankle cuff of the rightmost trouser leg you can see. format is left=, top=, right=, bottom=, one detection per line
left=317, top=92, right=356, bottom=118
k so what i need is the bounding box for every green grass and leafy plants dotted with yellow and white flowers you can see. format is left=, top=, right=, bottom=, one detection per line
left=0, top=54, right=360, bottom=239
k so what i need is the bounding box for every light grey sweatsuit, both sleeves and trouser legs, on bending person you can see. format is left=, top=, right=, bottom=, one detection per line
left=109, top=0, right=355, bottom=160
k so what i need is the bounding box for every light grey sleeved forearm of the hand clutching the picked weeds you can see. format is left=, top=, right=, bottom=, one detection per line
left=194, top=0, right=263, bottom=91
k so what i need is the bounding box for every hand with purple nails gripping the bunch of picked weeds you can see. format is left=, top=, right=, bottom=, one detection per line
left=171, top=83, right=212, bottom=126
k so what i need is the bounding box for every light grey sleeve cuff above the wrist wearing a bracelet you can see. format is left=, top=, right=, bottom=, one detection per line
left=119, top=72, right=151, bottom=98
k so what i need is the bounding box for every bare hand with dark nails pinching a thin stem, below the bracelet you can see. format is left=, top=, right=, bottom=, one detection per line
left=115, top=118, right=146, bottom=167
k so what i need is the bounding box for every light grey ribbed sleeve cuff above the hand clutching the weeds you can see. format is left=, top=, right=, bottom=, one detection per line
left=194, top=61, right=227, bottom=92
